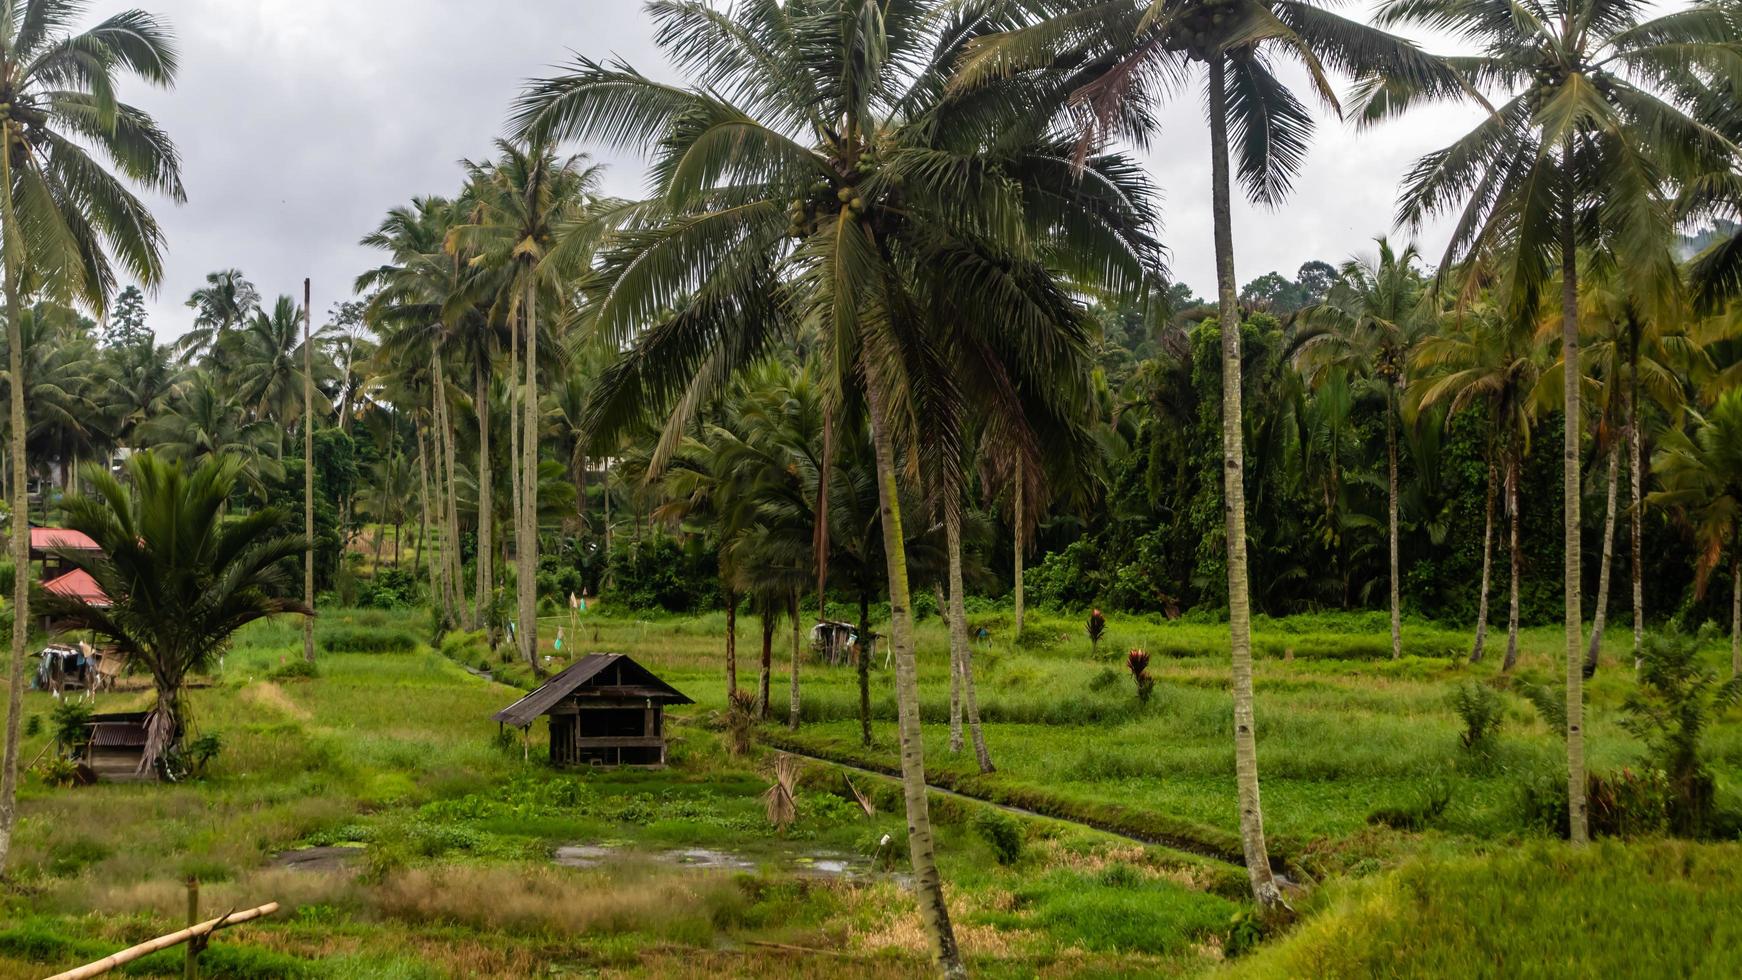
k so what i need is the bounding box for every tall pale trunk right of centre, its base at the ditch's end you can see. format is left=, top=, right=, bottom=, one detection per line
left=1209, top=56, right=1284, bottom=910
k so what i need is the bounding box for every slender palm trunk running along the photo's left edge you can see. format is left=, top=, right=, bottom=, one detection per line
left=0, top=271, right=30, bottom=874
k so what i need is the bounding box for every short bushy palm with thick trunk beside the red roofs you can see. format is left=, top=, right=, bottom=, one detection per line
left=44, top=453, right=314, bottom=771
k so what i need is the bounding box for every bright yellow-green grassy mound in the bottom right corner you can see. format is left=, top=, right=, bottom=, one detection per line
left=1228, top=841, right=1742, bottom=980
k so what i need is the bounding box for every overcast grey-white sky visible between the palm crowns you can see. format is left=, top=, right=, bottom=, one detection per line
left=119, top=0, right=1475, bottom=338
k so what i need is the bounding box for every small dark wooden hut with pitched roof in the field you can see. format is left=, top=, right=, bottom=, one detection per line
left=495, top=653, right=693, bottom=766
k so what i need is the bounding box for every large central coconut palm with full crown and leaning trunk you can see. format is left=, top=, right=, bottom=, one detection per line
left=516, top=0, right=1157, bottom=973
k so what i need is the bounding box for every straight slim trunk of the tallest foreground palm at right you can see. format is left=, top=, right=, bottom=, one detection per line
left=1561, top=180, right=1589, bottom=848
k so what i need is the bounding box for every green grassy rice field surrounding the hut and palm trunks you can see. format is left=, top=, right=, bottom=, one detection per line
left=0, top=606, right=1742, bottom=978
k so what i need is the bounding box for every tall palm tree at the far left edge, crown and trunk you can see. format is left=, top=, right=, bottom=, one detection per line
left=0, top=0, right=186, bottom=869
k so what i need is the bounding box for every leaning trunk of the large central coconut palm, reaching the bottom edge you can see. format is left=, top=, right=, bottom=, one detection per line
left=866, top=379, right=975, bottom=977
